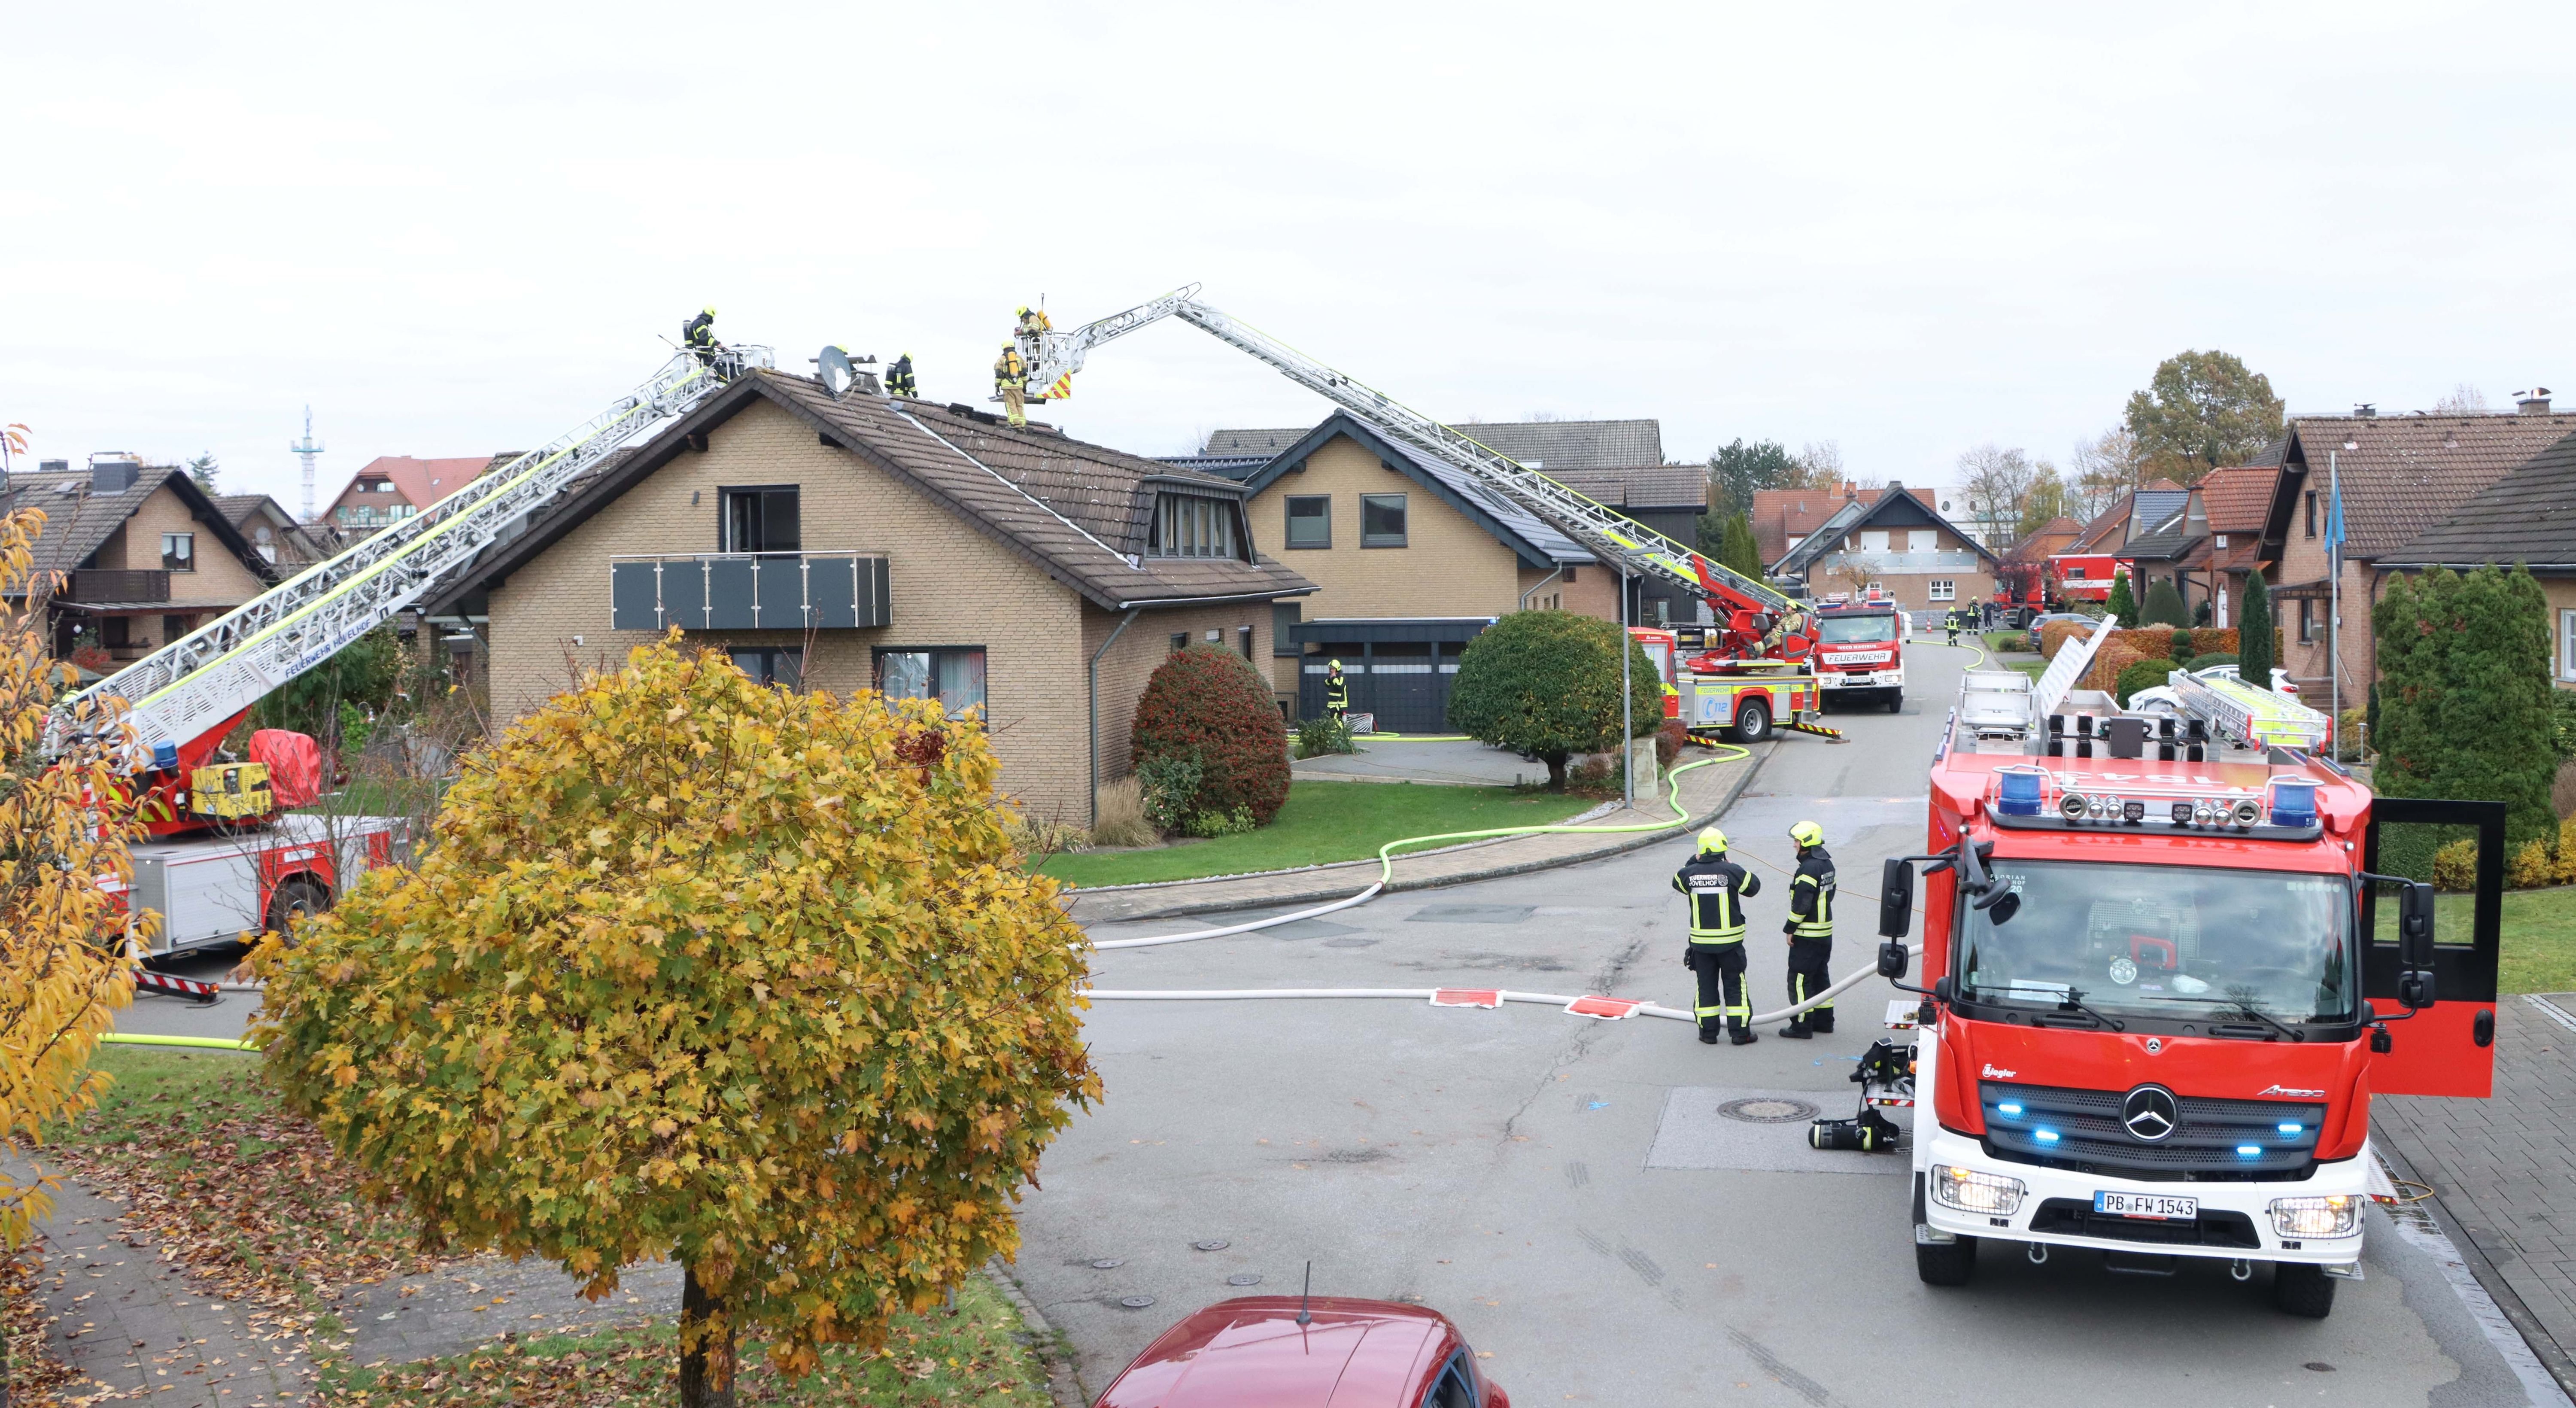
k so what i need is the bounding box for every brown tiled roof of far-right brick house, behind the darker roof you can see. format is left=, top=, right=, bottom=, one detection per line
left=2287, top=413, right=2576, bottom=557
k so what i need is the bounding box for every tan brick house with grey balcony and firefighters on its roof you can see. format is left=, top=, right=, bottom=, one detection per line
left=428, top=371, right=1316, bottom=825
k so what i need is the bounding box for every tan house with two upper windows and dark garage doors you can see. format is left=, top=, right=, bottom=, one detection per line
left=1190, top=410, right=1620, bottom=733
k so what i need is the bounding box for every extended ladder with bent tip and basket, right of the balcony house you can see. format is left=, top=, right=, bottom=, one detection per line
left=1020, top=284, right=1803, bottom=626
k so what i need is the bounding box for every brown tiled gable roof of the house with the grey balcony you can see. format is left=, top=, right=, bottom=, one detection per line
left=430, top=371, right=1314, bottom=614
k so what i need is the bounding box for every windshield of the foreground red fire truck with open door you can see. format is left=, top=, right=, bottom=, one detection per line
left=1958, top=859, right=2360, bottom=1021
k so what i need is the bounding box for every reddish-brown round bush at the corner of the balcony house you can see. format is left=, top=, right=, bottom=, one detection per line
left=1128, top=645, right=1288, bottom=825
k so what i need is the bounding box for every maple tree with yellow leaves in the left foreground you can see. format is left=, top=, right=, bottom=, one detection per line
left=252, top=642, right=1100, bottom=1408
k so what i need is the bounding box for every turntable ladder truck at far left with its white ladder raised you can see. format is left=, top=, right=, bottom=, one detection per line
left=54, top=348, right=770, bottom=998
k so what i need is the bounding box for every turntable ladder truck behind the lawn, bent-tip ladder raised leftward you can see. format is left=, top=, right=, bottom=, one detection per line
left=1015, top=284, right=1842, bottom=740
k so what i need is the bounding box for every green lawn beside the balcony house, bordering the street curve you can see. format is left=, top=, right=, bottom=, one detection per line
left=1038, top=782, right=1597, bottom=885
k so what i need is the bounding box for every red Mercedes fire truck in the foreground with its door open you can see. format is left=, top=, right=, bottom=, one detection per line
left=1878, top=645, right=2504, bottom=1318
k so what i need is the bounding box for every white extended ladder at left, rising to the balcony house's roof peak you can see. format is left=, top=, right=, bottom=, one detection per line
left=75, top=348, right=770, bottom=751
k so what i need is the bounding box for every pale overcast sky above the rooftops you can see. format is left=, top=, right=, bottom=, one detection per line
left=0, top=0, right=2576, bottom=505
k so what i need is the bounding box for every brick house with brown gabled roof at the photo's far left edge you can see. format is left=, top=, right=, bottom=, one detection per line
left=0, top=454, right=278, bottom=673
